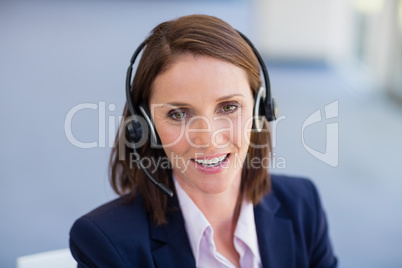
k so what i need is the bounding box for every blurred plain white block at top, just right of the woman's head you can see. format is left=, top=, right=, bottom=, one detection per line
left=253, top=0, right=356, bottom=64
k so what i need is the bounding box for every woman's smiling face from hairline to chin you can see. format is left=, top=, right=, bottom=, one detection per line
left=149, top=55, right=254, bottom=196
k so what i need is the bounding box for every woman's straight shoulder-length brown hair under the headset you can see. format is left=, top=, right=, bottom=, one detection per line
left=109, top=15, right=271, bottom=224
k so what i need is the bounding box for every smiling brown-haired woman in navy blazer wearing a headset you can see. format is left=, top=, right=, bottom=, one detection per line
left=70, top=15, right=336, bottom=267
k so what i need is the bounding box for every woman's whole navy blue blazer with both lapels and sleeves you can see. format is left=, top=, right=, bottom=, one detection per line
left=70, top=175, right=337, bottom=268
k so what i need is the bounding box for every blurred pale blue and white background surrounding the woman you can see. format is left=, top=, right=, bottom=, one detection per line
left=0, top=0, right=402, bottom=267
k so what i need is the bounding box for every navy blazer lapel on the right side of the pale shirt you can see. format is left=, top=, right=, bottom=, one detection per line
left=254, top=194, right=296, bottom=268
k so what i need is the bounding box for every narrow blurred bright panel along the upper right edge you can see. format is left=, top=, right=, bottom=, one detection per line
left=356, top=0, right=402, bottom=99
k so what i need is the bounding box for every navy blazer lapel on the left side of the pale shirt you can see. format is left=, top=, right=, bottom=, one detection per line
left=149, top=195, right=195, bottom=267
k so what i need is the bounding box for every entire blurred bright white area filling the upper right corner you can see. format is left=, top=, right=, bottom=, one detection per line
left=253, top=0, right=402, bottom=99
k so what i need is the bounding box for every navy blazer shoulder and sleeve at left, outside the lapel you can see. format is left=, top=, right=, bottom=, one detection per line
left=70, top=196, right=152, bottom=267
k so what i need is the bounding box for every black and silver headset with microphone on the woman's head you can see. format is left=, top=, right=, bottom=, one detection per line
left=126, top=31, right=278, bottom=197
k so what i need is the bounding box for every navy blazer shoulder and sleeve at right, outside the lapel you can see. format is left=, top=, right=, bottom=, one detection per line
left=262, top=175, right=337, bottom=267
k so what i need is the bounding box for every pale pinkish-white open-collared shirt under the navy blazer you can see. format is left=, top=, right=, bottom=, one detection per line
left=173, top=176, right=262, bottom=268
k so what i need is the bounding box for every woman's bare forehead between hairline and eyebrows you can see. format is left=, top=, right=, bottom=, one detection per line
left=150, top=54, right=252, bottom=104
